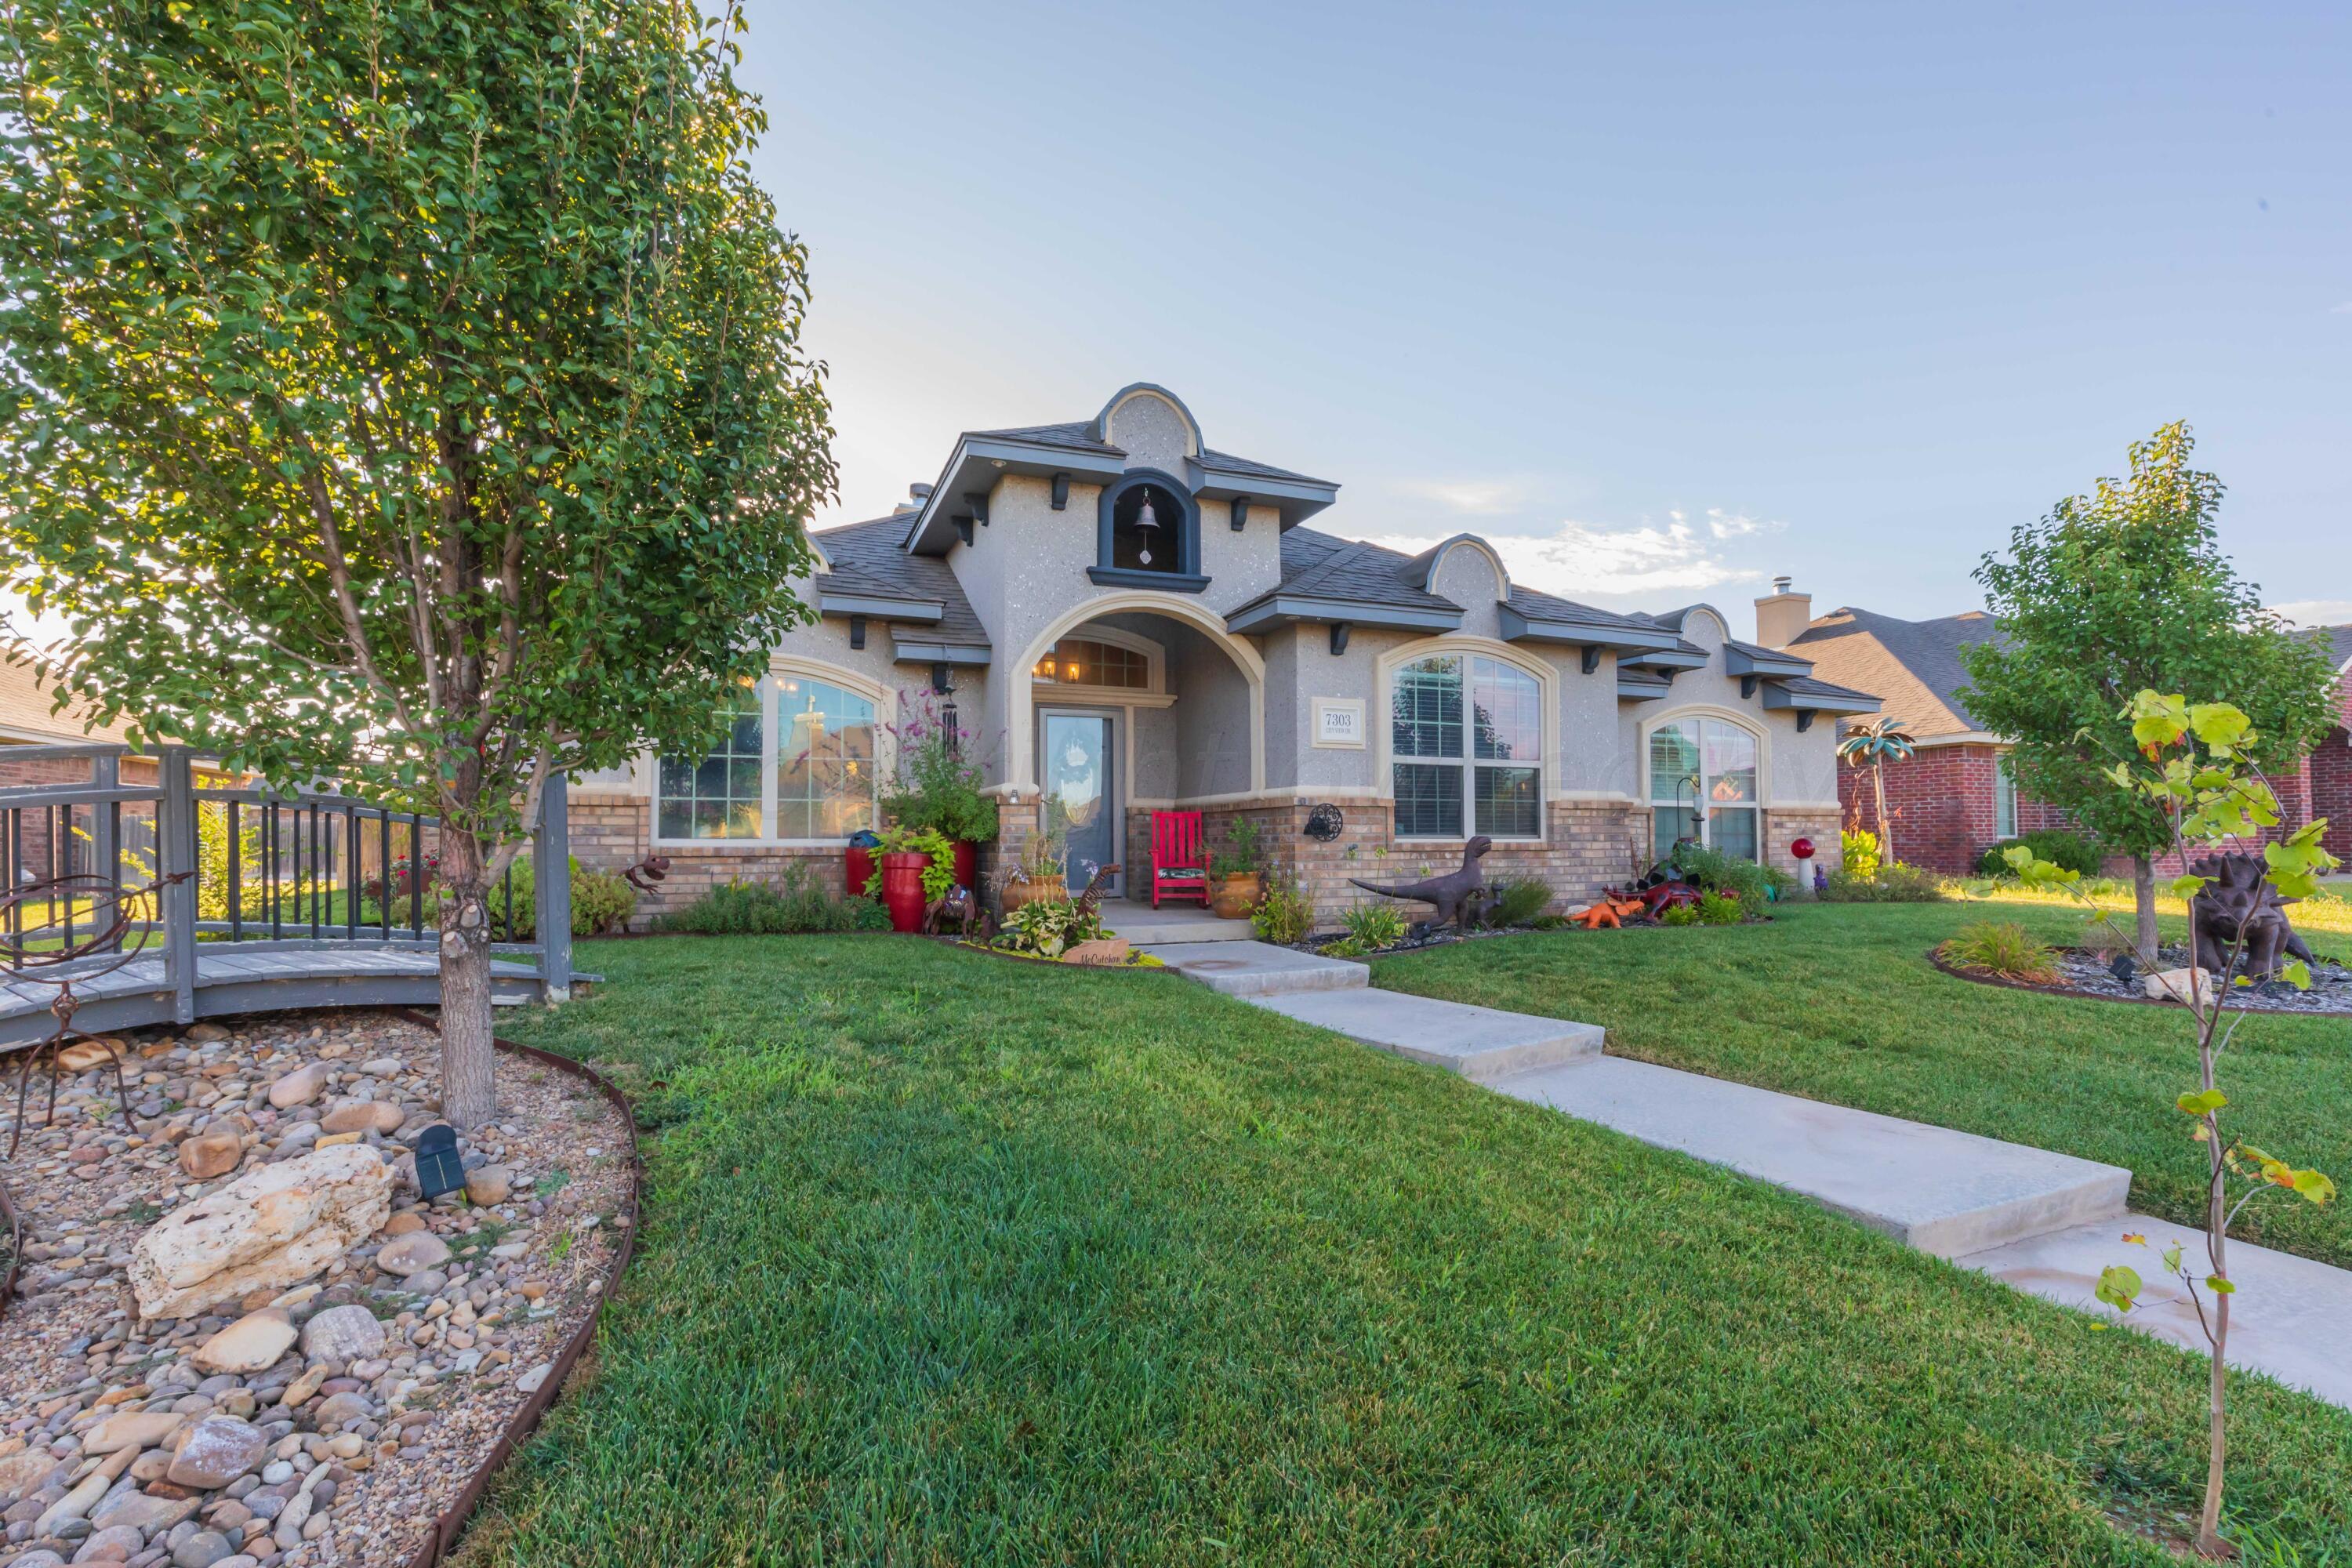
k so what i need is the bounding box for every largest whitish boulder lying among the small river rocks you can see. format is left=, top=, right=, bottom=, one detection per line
left=132, top=1142, right=393, bottom=1319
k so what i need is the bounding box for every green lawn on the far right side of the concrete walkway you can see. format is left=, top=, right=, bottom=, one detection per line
left=1374, top=900, right=2352, bottom=1265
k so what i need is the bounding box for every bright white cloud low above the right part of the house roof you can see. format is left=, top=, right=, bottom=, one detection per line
left=1371, top=508, right=1780, bottom=609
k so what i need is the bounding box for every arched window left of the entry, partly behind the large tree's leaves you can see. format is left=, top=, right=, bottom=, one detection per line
left=654, top=673, right=880, bottom=844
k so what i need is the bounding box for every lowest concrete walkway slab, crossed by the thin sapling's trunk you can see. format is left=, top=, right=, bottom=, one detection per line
left=1955, top=1213, right=2352, bottom=1406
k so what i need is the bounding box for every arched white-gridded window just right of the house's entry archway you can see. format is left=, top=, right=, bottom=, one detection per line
left=1388, top=654, right=1543, bottom=839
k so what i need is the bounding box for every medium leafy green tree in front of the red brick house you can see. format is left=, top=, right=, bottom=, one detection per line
left=1962, top=423, right=2333, bottom=961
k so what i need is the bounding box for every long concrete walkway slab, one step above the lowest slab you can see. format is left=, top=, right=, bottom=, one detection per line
left=1494, top=1055, right=2138, bottom=1262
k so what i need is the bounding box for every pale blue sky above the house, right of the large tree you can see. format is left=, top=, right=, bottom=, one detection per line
left=746, top=0, right=2352, bottom=639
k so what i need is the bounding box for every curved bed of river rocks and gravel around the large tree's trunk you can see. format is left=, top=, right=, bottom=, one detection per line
left=0, top=1011, right=635, bottom=1568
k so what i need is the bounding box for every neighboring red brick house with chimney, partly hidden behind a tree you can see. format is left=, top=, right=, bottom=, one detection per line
left=1757, top=579, right=2352, bottom=872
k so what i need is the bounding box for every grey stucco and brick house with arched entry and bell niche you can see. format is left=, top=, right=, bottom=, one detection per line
left=569, top=383, right=1877, bottom=916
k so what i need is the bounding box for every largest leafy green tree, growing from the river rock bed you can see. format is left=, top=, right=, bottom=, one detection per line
left=0, top=0, right=833, bottom=1126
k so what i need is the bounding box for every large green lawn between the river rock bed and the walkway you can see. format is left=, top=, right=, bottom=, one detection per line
left=482, top=933, right=2352, bottom=1568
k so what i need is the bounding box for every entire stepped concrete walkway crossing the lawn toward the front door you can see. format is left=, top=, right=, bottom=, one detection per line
left=1150, top=921, right=2352, bottom=1408
